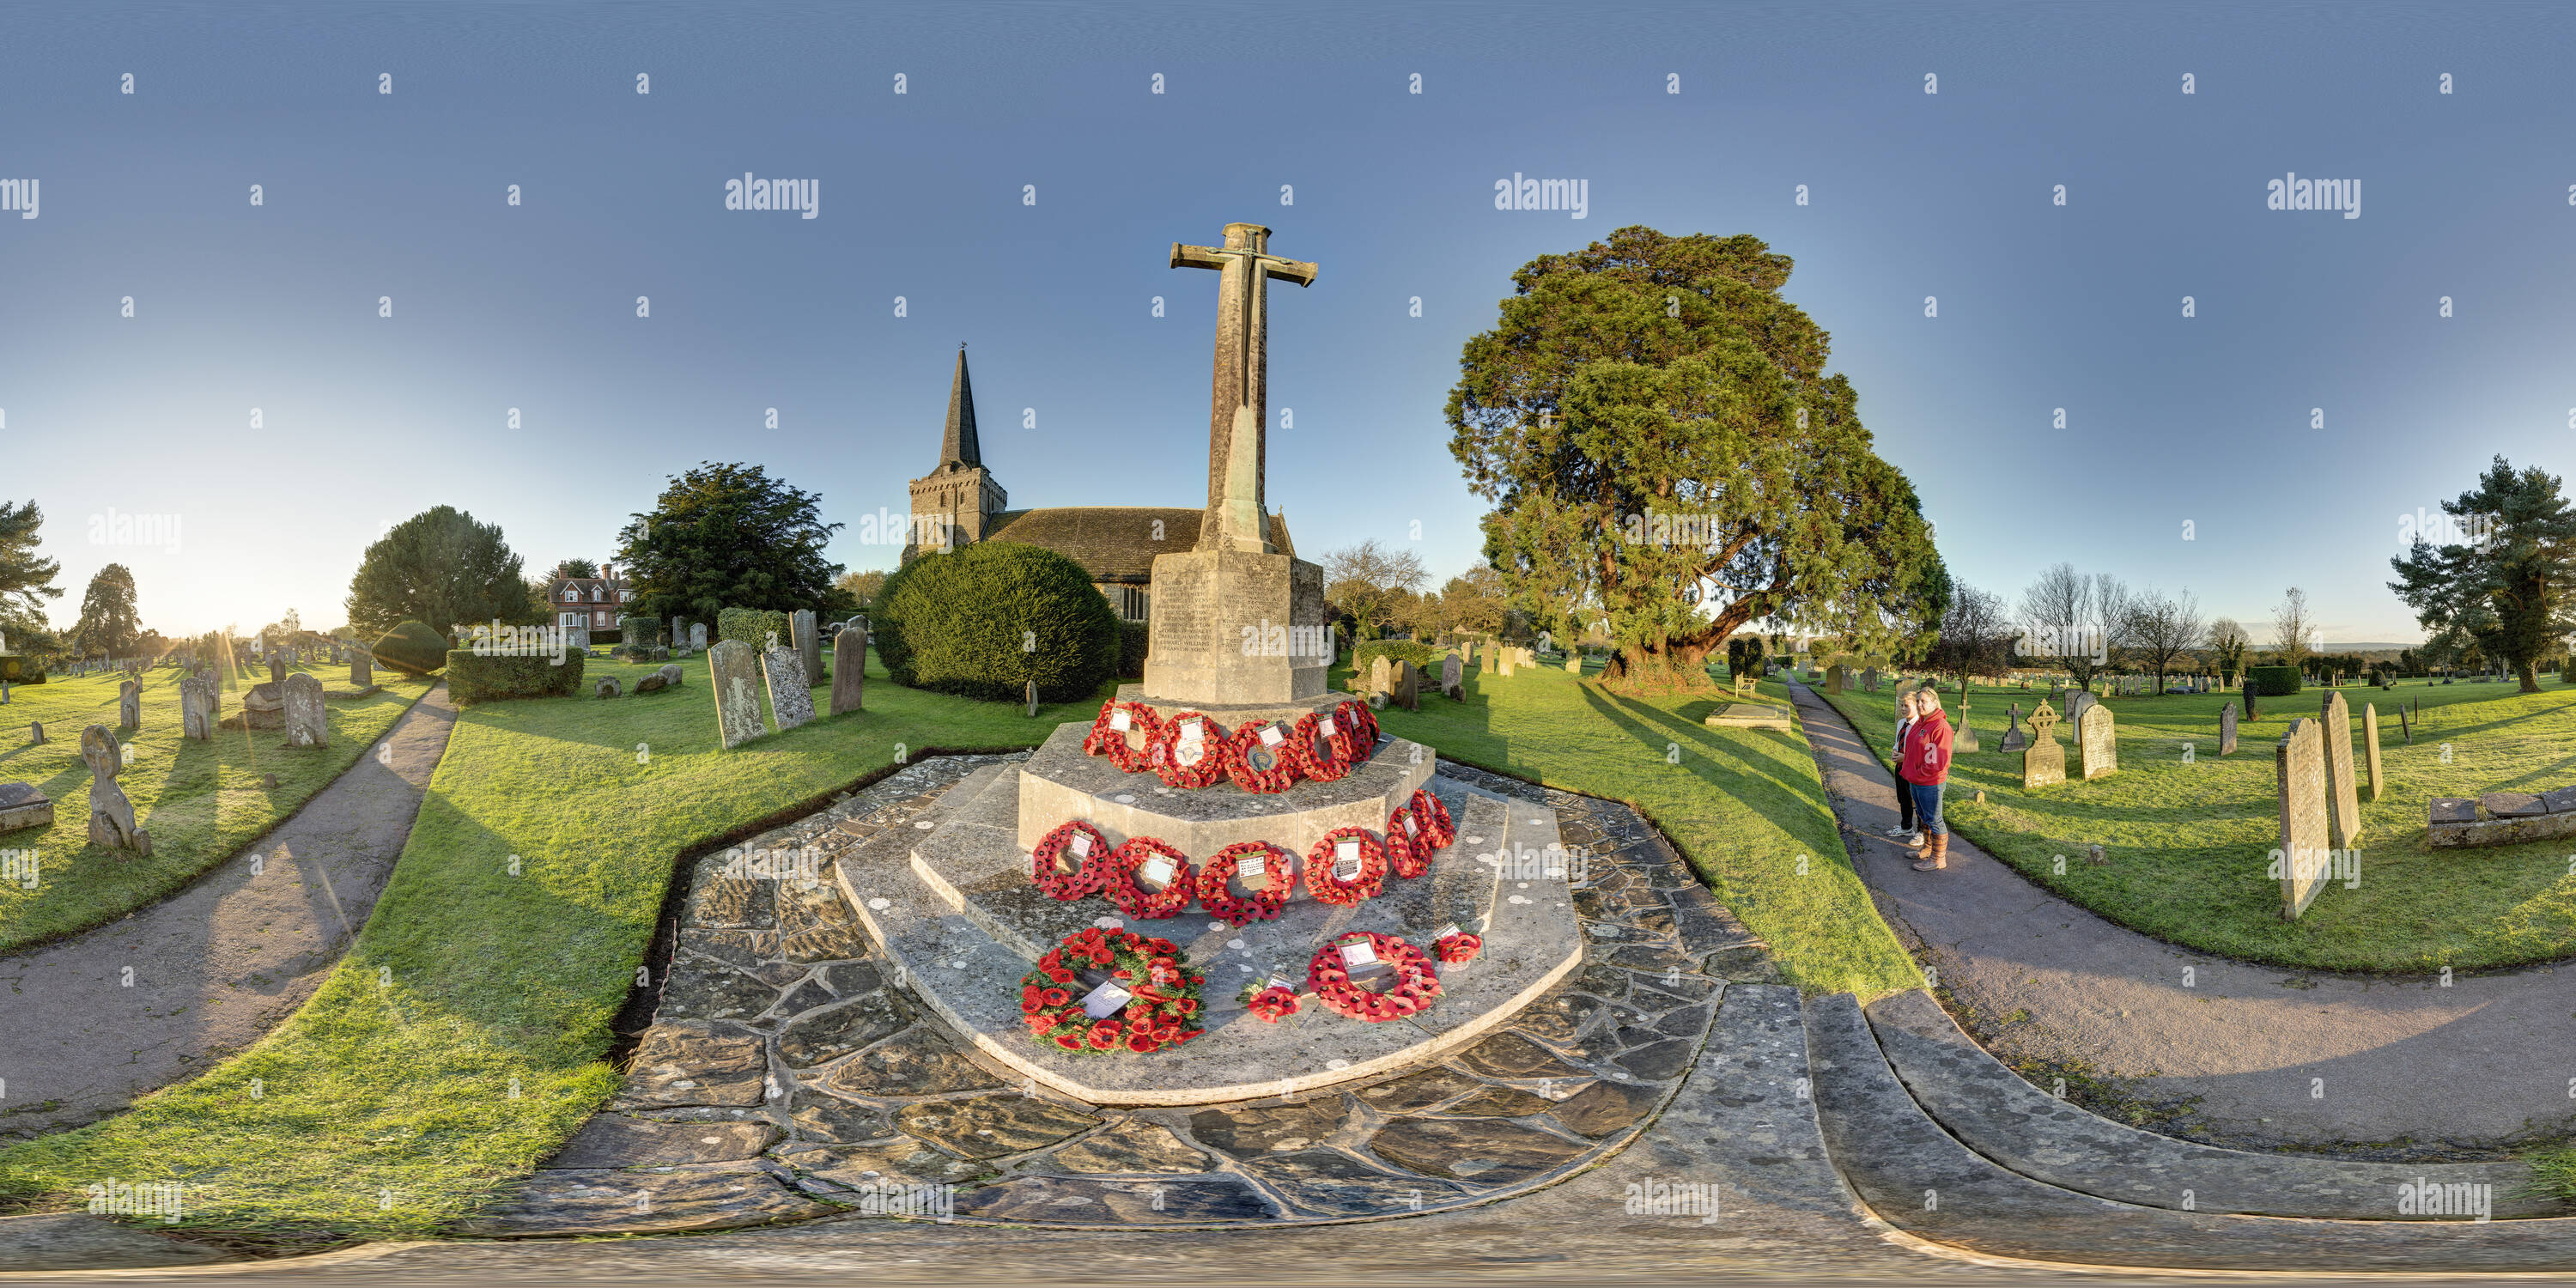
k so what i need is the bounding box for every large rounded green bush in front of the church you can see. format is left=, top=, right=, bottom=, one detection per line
left=868, top=541, right=1118, bottom=703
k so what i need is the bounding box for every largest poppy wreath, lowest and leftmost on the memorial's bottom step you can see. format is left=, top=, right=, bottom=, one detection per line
left=1020, top=927, right=1206, bottom=1056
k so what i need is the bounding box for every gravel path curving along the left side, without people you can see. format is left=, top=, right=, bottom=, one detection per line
left=0, top=685, right=456, bottom=1139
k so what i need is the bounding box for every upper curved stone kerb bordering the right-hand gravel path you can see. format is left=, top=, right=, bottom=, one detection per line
left=1865, top=989, right=2566, bottom=1221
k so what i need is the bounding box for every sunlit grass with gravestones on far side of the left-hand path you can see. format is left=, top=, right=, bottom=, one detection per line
left=0, top=665, right=430, bottom=953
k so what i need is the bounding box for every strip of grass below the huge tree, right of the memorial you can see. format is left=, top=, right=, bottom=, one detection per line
left=1381, top=667, right=1922, bottom=1002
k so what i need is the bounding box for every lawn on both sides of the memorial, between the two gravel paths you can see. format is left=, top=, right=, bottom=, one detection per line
left=0, top=659, right=1917, bottom=1236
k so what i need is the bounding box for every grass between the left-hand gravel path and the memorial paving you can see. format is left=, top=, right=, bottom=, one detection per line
left=0, top=657, right=1105, bottom=1236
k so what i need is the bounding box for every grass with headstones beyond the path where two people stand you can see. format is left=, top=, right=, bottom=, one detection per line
left=1819, top=677, right=2576, bottom=974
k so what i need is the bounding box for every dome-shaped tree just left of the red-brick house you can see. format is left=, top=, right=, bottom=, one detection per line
left=345, top=505, right=536, bottom=639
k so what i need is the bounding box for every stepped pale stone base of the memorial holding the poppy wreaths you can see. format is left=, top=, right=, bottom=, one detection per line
left=835, top=724, right=1584, bottom=1105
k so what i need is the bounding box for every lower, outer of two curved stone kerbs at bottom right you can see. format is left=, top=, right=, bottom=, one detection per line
left=1806, top=994, right=2576, bottom=1275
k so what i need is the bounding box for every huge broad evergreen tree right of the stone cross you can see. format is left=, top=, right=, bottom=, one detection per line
left=1448, top=227, right=1940, bottom=688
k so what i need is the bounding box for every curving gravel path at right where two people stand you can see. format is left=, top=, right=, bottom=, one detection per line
left=1790, top=685, right=2576, bottom=1157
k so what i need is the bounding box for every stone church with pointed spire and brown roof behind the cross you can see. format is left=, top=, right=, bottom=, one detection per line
left=904, top=345, right=1296, bottom=621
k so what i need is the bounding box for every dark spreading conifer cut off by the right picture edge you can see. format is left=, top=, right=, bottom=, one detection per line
left=2388, top=456, right=2576, bottom=693
